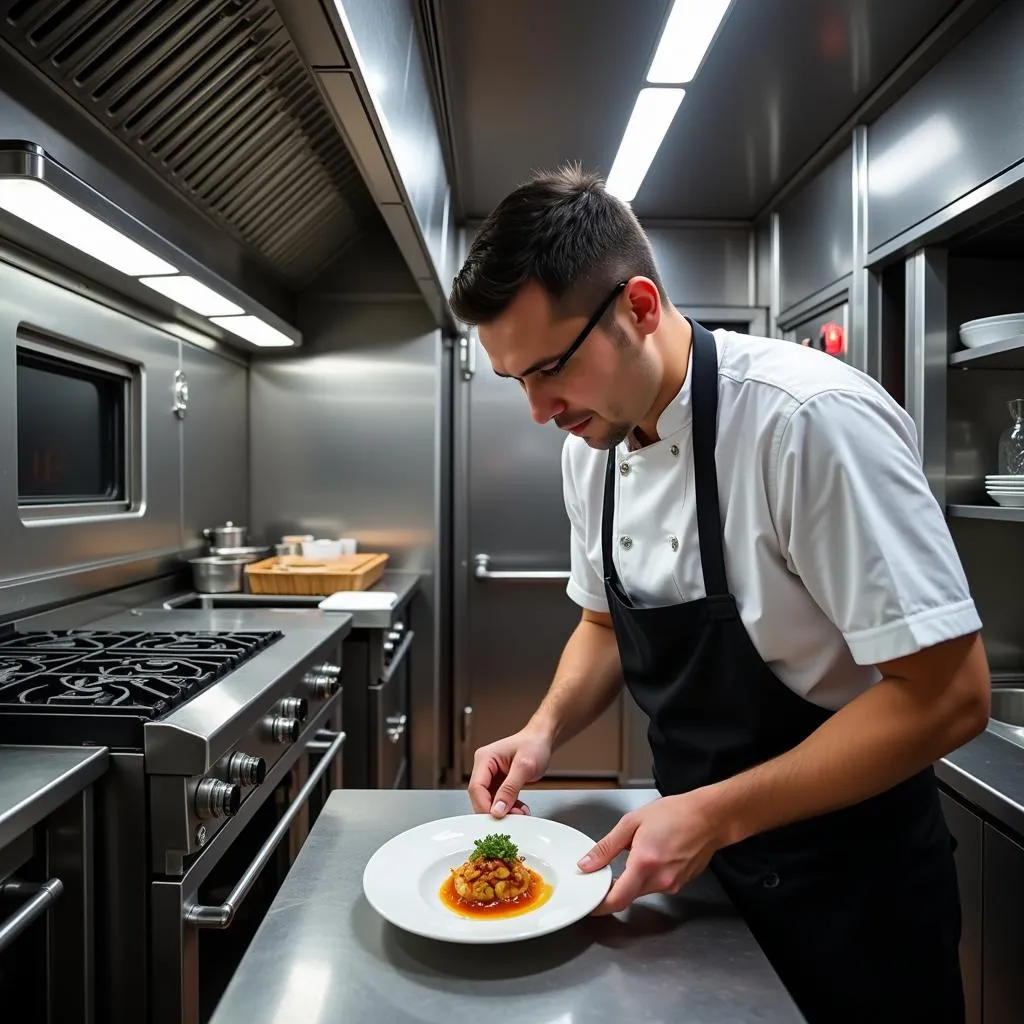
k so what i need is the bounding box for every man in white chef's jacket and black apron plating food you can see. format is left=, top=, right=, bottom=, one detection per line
left=451, top=167, right=989, bottom=1024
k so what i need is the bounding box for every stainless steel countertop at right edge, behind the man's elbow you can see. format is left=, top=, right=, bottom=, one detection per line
left=935, top=727, right=1024, bottom=838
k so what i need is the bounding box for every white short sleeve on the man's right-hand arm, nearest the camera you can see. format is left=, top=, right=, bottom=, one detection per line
left=773, top=390, right=981, bottom=665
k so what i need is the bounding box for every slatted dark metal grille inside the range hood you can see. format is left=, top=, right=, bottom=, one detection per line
left=0, top=0, right=379, bottom=288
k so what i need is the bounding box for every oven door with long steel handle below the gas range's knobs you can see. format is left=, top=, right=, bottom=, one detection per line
left=150, top=729, right=345, bottom=1024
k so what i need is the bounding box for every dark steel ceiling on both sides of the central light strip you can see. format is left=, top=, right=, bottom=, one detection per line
left=433, top=0, right=957, bottom=219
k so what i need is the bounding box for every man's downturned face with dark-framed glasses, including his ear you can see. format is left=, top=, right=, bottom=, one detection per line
left=478, top=278, right=660, bottom=449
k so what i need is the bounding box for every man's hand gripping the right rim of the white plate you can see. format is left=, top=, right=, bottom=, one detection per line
left=579, top=793, right=723, bottom=914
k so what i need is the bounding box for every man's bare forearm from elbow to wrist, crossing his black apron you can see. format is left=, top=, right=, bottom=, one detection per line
left=703, top=637, right=989, bottom=845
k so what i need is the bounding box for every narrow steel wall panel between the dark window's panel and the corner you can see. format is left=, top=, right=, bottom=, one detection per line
left=181, top=344, right=249, bottom=549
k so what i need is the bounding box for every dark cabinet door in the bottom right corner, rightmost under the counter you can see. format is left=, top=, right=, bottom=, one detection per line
left=982, top=824, right=1024, bottom=1024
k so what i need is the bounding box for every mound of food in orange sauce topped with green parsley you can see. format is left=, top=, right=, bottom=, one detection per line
left=439, top=833, right=552, bottom=918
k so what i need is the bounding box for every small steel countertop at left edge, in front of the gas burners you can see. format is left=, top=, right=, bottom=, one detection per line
left=0, top=746, right=108, bottom=849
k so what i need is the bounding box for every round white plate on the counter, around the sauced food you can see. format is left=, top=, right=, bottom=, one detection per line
left=362, top=814, right=611, bottom=943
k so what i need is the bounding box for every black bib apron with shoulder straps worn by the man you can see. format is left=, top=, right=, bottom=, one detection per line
left=601, top=321, right=964, bottom=1024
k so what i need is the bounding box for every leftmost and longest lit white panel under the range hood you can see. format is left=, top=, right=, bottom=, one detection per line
left=0, top=178, right=177, bottom=275
